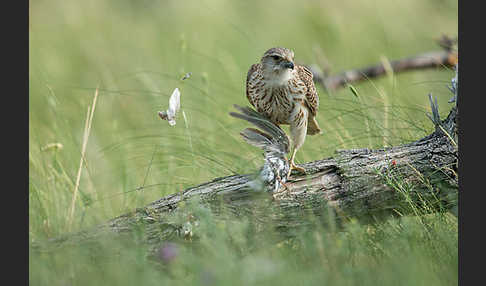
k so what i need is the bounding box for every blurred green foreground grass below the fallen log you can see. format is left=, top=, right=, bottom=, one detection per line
left=30, top=202, right=458, bottom=285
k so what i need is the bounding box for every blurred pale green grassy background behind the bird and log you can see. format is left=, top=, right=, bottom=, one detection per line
left=29, top=0, right=458, bottom=284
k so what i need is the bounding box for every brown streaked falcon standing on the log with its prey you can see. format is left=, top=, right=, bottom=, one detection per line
left=246, top=48, right=321, bottom=176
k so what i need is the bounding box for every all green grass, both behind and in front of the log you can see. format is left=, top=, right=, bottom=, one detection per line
left=29, top=0, right=457, bottom=285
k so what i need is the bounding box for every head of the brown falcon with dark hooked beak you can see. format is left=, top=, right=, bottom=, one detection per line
left=260, top=48, right=294, bottom=80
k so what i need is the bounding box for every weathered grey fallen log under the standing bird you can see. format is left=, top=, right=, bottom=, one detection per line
left=32, top=95, right=458, bottom=254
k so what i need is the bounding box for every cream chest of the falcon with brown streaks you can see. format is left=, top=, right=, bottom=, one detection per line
left=255, top=84, right=304, bottom=124
